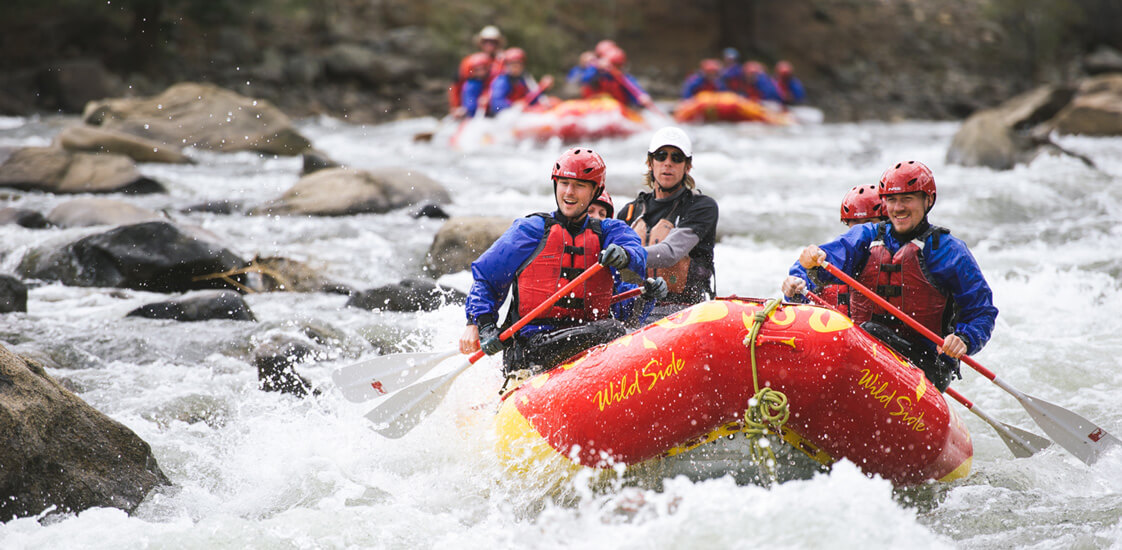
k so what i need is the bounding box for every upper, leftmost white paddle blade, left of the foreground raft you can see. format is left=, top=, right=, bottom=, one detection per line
left=331, top=349, right=458, bottom=403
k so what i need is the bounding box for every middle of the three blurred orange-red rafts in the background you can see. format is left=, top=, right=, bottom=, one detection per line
left=512, top=95, right=649, bottom=141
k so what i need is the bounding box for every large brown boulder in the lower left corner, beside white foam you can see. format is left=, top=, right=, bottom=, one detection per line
left=0, top=346, right=169, bottom=522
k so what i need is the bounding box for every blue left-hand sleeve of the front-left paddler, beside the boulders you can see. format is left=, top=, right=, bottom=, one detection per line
left=465, top=216, right=545, bottom=324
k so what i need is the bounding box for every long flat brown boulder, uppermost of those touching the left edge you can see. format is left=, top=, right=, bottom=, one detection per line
left=0, top=147, right=165, bottom=193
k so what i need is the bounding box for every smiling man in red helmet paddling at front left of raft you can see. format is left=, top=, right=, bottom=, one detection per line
left=460, top=147, right=665, bottom=377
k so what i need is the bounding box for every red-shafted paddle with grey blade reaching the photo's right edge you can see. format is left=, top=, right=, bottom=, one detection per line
left=821, top=262, right=1122, bottom=465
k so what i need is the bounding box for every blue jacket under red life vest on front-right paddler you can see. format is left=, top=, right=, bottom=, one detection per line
left=790, top=223, right=997, bottom=355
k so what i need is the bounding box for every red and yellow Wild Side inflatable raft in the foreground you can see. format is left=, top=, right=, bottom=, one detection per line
left=496, top=299, right=973, bottom=485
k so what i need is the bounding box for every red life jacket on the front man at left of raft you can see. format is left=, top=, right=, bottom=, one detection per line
left=511, top=214, right=614, bottom=324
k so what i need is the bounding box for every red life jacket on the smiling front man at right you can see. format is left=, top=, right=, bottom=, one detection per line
left=849, top=222, right=955, bottom=336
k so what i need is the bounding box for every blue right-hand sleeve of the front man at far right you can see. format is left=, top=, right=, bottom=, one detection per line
left=927, top=235, right=997, bottom=355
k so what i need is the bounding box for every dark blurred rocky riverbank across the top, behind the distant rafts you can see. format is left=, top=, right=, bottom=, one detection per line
left=0, top=0, right=1122, bottom=123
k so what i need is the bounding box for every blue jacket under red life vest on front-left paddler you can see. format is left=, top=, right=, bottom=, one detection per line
left=465, top=211, right=646, bottom=337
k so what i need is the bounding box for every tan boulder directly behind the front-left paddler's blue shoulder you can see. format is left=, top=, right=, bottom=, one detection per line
left=425, top=217, right=513, bottom=277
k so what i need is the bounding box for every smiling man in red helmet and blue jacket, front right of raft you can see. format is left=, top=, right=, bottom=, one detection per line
left=782, top=161, right=997, bottom=392
